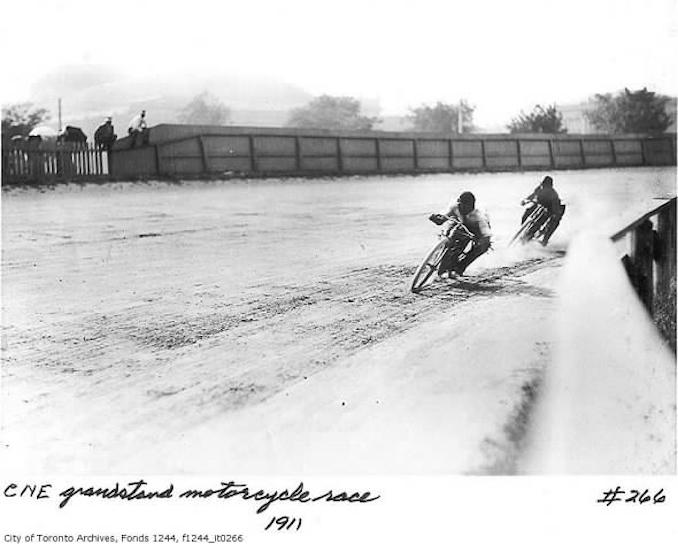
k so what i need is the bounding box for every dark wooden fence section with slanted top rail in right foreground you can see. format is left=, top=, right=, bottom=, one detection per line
left=612, top=198, right=677, bottom=350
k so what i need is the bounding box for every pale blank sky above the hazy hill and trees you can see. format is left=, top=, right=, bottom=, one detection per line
left=0, top=0, right=678, bottom=125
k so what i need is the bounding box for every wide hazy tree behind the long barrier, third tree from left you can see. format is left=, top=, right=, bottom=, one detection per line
left=287, top=95, right=378, bottom=130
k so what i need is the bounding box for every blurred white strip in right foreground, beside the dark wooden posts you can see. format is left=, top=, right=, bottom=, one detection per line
left=518, top=233, right=676, bottom=475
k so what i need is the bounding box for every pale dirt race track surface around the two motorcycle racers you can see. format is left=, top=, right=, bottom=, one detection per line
left=0, top=169, right=675, bottom=474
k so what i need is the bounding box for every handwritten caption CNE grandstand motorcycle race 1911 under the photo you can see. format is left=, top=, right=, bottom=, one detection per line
left=3, top=479, right=381, bottom=532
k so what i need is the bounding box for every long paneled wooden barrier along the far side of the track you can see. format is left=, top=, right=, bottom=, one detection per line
left=111, top=125, right=676, bottom=178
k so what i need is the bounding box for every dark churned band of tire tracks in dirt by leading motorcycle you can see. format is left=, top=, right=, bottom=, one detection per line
left=5, top=255, right=561, bottom=440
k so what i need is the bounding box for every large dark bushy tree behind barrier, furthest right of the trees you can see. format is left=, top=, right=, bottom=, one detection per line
left=585, top=88, right=671, bottom=134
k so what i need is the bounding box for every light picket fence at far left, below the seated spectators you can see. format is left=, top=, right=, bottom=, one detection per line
left=2, top=142, right=109, bottom=184
